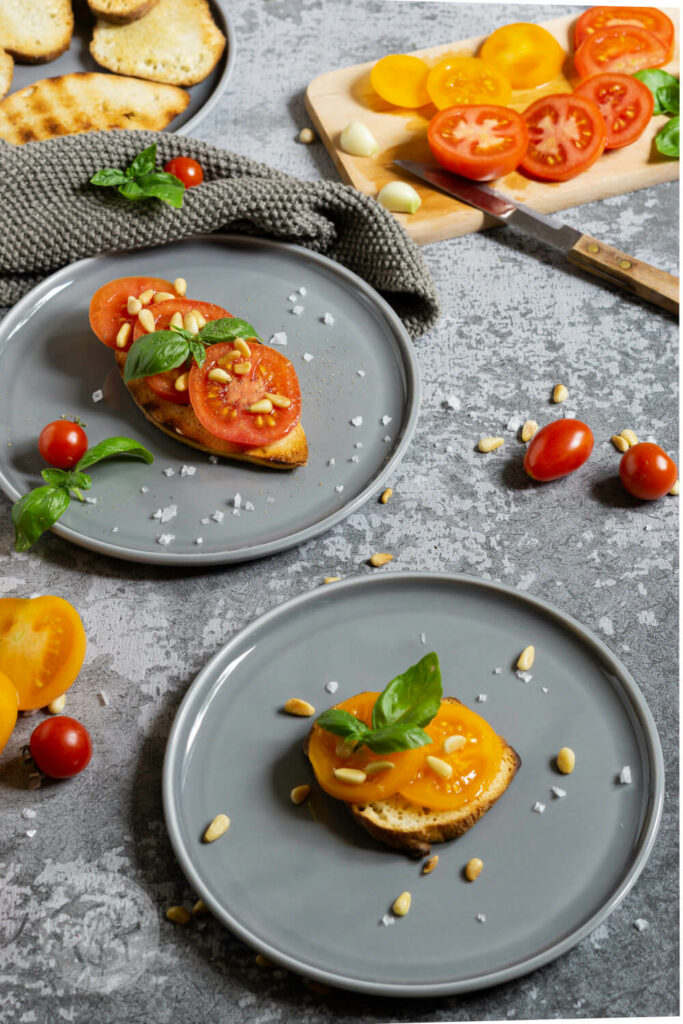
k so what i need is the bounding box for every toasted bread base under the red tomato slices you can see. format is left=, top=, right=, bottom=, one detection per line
left=114, top=352, right=308, bottom=469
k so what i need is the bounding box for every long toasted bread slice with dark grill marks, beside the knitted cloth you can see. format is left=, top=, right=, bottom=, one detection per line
left=0, top=72, right=189, bottom=145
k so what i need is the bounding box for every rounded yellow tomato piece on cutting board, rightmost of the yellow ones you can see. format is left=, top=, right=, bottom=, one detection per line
left=479, top=22, right=565, bottom=89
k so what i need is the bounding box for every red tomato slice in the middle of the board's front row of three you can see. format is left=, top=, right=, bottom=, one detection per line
left=520, top=93, right=607, bottom=181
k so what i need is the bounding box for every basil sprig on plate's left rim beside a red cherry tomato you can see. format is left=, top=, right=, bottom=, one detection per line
left=12, top=437, right=154, bottom=551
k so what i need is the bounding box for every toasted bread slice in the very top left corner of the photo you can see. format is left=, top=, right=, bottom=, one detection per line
left=0, top=0, right=74, bottom=63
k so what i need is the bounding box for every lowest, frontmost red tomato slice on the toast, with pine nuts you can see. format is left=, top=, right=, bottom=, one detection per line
left=189, top=338, right=301, bottom=447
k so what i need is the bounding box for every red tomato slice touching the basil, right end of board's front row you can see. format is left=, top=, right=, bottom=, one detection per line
left=577, top=72, right=654, bottom=150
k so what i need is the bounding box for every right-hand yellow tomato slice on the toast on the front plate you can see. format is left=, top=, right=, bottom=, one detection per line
left=399, top=700, right=503, bottom=811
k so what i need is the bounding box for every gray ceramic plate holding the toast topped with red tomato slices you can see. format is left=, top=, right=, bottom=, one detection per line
left=0, top=236, right=420, bottom=565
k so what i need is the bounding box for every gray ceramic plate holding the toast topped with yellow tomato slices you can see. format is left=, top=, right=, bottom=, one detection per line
left=164, top=573, right=664, bottom=996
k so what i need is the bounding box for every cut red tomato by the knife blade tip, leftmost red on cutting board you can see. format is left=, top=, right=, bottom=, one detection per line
left=427, top=104, right=528, bottom=181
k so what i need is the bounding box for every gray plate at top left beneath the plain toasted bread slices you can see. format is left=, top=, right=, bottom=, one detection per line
left=9, top=0, right=234, bottom=135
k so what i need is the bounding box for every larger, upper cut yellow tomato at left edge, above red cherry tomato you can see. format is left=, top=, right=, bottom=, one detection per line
left=0, top=597, right=85, bottom=711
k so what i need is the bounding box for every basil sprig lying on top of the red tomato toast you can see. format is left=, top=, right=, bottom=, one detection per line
left=124, top=316, right=258, bottom=384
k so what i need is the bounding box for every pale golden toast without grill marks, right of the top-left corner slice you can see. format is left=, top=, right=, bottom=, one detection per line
left=90, top=0, right=225, bottom=85
